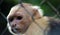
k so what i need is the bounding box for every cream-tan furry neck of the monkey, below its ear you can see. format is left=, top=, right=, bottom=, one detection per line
left=22, top=17, right=48, bottom=35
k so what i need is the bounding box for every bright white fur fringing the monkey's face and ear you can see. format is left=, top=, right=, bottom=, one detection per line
left=7, top=5, right=43, bottom=35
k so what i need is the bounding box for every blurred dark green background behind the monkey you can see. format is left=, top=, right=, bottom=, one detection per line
left=0, top=0, right=60, bottom=35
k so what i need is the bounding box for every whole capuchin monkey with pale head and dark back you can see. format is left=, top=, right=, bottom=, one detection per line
left=7, top=3, right=60, bottom=35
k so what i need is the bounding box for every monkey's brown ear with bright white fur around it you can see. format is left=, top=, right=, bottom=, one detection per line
left=33, top=6, right=43, bottom=19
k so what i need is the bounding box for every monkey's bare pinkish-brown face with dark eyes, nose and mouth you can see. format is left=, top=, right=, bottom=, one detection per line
left=7, top=8, right=32, bottom=34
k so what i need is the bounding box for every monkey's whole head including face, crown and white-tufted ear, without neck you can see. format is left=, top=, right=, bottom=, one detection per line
left=7, top=3, right=43, bottom=34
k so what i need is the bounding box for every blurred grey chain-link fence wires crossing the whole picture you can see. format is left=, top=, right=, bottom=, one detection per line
left=0, top=0, right=60, bottom=35
